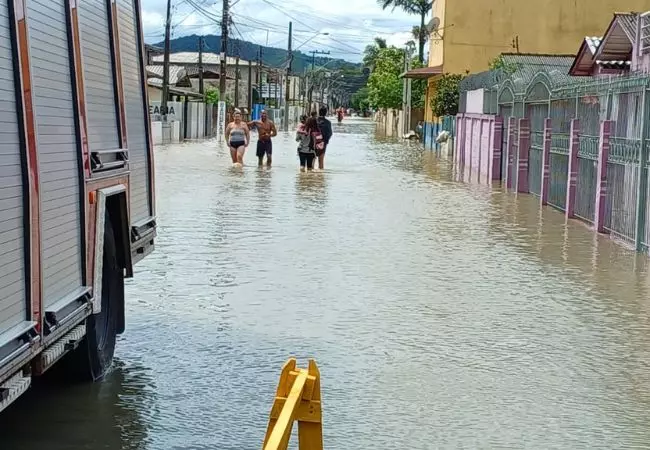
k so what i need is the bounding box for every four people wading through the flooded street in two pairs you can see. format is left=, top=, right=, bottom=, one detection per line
left=224, top=106, right=340, bottom=172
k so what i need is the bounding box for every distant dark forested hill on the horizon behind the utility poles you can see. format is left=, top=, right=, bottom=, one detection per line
left=154, top=34, right=361, bottom=73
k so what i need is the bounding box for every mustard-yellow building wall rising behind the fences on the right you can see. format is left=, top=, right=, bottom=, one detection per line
left=416, top=0, right=648, bottom=121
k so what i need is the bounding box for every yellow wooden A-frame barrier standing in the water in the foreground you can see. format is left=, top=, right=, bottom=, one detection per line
left=264, top=358, right=323, bottom=450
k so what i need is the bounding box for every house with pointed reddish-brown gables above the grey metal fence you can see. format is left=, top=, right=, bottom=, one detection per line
left=569, top=12, right=650, bottom=76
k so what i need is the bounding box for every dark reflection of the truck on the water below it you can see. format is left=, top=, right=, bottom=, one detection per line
left=0, top=360, right=158, bottom=450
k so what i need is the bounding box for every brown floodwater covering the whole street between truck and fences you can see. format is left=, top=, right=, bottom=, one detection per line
left=0, top=119, right=650, bottom=450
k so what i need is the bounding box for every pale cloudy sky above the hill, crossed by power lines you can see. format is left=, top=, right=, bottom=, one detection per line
left=142, top=0, right=419, bottom=62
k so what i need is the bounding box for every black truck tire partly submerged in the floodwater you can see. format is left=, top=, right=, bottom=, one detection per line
left=63, top=214, right=124, bottom=381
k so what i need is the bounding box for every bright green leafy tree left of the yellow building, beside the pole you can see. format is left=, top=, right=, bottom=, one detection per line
left=368, top=47, right=404, bottom=108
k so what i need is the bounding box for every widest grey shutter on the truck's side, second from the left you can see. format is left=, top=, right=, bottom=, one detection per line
left=27, top=0, right=85, bottom=311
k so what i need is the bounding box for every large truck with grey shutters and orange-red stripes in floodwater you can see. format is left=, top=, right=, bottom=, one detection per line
left=0, top=0, right=156, bottom=411
